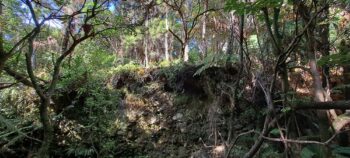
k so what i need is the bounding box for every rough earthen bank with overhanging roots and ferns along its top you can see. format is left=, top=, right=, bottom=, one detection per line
left=109, top=66, right=258, bottom=158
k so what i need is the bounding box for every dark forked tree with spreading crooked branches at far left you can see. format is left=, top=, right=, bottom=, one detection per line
left=1, top=0, right=139, bottom=157
